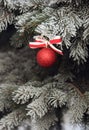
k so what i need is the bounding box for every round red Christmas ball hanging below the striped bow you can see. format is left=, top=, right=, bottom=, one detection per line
left=36, top=48, right=57, bottom=67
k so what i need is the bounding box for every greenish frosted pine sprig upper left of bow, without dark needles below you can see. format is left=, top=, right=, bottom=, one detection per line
left=16, top=11, right=48, bottom=32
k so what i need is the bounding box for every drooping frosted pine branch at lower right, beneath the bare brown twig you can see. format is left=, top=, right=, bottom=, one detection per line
left=67, top=83, right=89, bottom=124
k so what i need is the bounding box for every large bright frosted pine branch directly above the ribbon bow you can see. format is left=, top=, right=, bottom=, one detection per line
left=36, top=7, right=83, bottom=43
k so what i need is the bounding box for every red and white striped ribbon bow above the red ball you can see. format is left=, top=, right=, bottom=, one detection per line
left=29, top=36, right=63, bottom=55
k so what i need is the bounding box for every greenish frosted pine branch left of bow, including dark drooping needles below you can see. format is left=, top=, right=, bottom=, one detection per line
left=11, top=11, right=48, bottom=47
